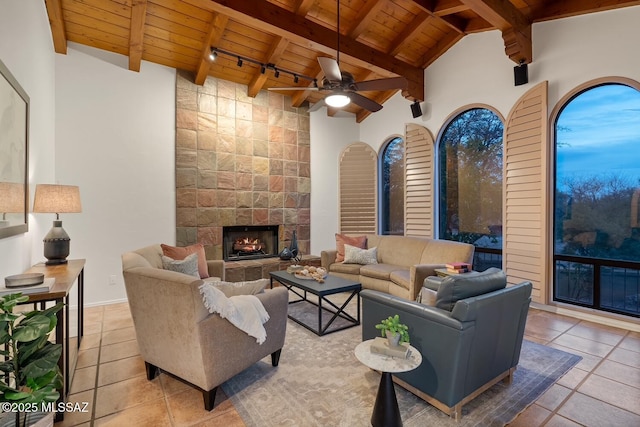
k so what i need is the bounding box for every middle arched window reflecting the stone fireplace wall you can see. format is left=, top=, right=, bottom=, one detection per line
left=438, top=108, right=503, bottom=271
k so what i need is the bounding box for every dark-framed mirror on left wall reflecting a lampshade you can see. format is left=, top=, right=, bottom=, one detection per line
left=0, top=60, right=29, bottom=239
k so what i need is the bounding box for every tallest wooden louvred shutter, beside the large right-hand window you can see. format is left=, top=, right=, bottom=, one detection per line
left=503, top=82, right=549, bottom=303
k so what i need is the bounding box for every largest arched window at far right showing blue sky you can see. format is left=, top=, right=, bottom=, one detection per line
left=553, top=82, right=640, bottom=317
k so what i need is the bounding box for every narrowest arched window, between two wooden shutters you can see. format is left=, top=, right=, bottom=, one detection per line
left=378, top=137, right=404, bottom=235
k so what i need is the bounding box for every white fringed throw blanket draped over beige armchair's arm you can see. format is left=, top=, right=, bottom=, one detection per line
left=200, top=283, right=269, bottom=344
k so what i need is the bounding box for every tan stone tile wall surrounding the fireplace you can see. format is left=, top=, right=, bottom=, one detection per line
left=175, top=72, right=311, bottom=259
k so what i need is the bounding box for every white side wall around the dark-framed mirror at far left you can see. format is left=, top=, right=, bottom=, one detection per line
left=0, top=0, right=55, bottom=283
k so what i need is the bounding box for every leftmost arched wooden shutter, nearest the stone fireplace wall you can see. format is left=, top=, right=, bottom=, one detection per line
left=338, top=142, right=378, bottom=234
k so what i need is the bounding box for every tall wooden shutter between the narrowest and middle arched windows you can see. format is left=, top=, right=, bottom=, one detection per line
left=404, top=124, right=433, bottom=238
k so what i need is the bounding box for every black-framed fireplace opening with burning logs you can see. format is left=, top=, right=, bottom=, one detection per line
left=222, top=225, right=279, bottom=261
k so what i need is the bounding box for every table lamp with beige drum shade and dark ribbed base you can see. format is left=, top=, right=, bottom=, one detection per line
left=33, top=184, right=82, bottom=265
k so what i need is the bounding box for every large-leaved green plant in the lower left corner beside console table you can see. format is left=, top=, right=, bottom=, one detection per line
left=0, top=293, right=64, bottom=426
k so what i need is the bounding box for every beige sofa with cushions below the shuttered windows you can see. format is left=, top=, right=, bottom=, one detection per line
left=320, top=234, right=474, bottom=300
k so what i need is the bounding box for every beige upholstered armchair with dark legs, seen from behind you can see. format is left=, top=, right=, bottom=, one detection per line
left=122, top=245, right=288, bottom=410
